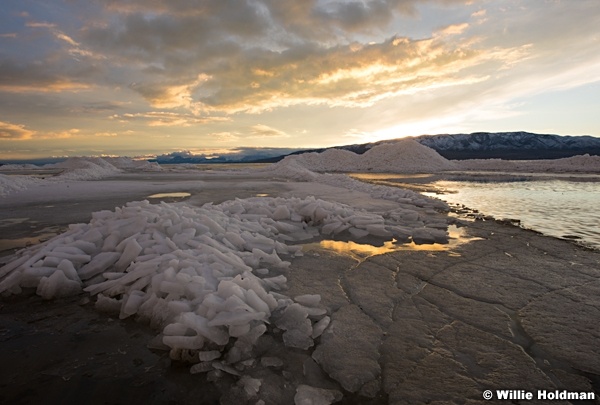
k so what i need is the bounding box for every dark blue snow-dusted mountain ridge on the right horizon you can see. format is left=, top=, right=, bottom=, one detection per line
left=415, top=132, right=600, bottom=159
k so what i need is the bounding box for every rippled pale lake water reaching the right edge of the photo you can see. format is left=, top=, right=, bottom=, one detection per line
left=424, top=179, right=600, bottom=249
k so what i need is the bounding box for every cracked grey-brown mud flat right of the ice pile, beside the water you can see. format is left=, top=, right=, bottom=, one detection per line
left=290, top=221, right=600, bottom=404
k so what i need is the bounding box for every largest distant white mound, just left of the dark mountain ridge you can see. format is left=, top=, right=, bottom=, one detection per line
left=275, top=139, right=456, bottom=173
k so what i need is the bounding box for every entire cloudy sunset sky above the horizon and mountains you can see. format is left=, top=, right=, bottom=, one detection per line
left=0, top=0, right=600, bottom=159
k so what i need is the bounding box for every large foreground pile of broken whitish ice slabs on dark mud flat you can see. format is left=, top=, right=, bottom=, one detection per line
left=0, top=193, right=447, bottom=400
